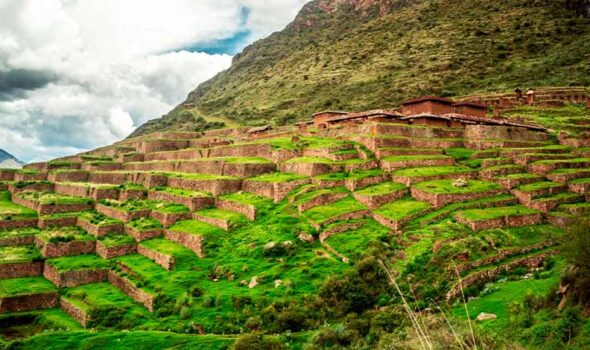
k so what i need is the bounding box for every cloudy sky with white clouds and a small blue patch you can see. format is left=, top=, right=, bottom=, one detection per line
left=0, top=0, right=307, bottom=162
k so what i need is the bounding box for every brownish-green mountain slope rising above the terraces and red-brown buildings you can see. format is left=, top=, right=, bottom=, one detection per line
left=132, top=0, right=590, bottom=136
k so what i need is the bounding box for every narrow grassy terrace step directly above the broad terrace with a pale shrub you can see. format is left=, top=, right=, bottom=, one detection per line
left=391, top=166, right=477, bottom=186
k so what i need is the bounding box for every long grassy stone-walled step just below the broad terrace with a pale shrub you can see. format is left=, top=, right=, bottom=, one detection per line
left=453, top=205, right=541, bottom=231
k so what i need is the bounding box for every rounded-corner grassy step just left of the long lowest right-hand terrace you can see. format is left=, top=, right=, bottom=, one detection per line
left=373, top=199, right=432, bottom=231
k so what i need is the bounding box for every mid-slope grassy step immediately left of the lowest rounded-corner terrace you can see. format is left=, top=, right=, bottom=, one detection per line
left=303, top=196, right=369, bottom=229
